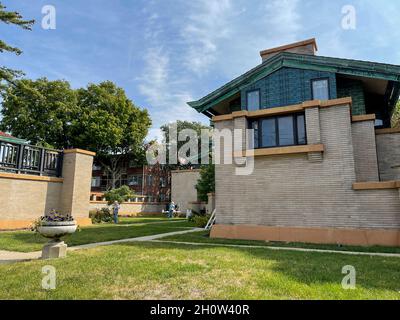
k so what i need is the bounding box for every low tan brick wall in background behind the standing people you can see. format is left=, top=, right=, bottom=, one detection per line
left=90, top=201, right=167, bottom=216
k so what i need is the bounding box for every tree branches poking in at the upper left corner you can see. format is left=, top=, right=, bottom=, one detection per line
left=0, top=2, right=35, bottom=82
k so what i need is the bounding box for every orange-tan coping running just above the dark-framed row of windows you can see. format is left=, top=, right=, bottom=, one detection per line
left=212, top=97, right=352, bottom=122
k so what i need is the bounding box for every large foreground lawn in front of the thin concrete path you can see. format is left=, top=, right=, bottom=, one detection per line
left=0, top=243, right=400, bottom=299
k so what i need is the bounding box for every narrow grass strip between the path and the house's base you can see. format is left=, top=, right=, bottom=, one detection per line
left=161, top=231, right=400, bottom=253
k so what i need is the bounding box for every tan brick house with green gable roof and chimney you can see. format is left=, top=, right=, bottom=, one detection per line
left=189, top=39, right=400, bottom=246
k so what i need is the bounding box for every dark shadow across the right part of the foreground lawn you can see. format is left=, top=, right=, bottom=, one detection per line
left=106, top=242, right=400, bottom=298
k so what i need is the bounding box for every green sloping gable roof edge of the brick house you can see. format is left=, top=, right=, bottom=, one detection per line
left=188, top=52, right=400, bottom=112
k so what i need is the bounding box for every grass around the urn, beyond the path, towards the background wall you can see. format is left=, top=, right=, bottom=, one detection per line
left=0, top=218, right=193, bottom=252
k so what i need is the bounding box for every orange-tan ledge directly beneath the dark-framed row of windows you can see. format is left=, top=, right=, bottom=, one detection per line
left=234, top=144, right=324, bottom=157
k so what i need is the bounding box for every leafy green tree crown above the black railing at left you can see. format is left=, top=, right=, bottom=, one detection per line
left=0, top=78, right=78, bottom=149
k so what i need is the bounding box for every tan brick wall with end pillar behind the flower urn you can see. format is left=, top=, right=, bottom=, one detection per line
left=0, top=149, right=94, bottom=230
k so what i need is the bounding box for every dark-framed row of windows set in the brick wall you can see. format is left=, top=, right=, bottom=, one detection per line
left=250, top=113, right=307, bottom=149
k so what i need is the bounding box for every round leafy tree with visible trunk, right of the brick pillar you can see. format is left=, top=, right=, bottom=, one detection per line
left=72, top=81, right=151, bottom=188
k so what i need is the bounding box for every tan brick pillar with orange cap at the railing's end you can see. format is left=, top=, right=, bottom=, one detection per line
left=60, top=149, right=95, bottom=225
